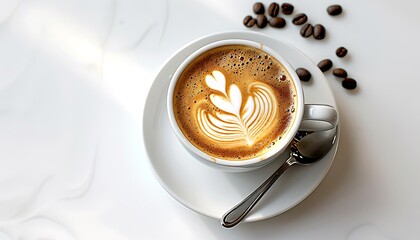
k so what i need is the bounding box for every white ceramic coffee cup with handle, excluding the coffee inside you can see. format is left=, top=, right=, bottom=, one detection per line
left=167, top=39, right=338, bottom=172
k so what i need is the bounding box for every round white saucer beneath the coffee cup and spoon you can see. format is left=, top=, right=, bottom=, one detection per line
left=143, top=32, right=339, bottom=222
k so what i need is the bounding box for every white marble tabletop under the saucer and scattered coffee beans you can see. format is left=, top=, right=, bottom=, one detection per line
left=0, top=0, right=420, bottom=240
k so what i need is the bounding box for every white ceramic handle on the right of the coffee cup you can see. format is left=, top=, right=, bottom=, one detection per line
left=299, top=104, right=338, bottom=132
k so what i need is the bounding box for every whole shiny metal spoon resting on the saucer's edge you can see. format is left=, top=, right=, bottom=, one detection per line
left=221, top=128, right=337, bottom=228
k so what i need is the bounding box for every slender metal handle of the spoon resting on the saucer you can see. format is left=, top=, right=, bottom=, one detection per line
left=221, top=156, right=296, bottom=228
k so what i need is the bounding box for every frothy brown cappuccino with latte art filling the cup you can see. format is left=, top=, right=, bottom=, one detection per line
left=172, top=45, right=296, bottom=161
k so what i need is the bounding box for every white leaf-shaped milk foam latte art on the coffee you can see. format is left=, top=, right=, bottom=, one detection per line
left=197, top=71, right=278, bottom=146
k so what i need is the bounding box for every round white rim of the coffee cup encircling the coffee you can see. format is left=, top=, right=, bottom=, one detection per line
left=167, top=39, right=304, bottom=167
